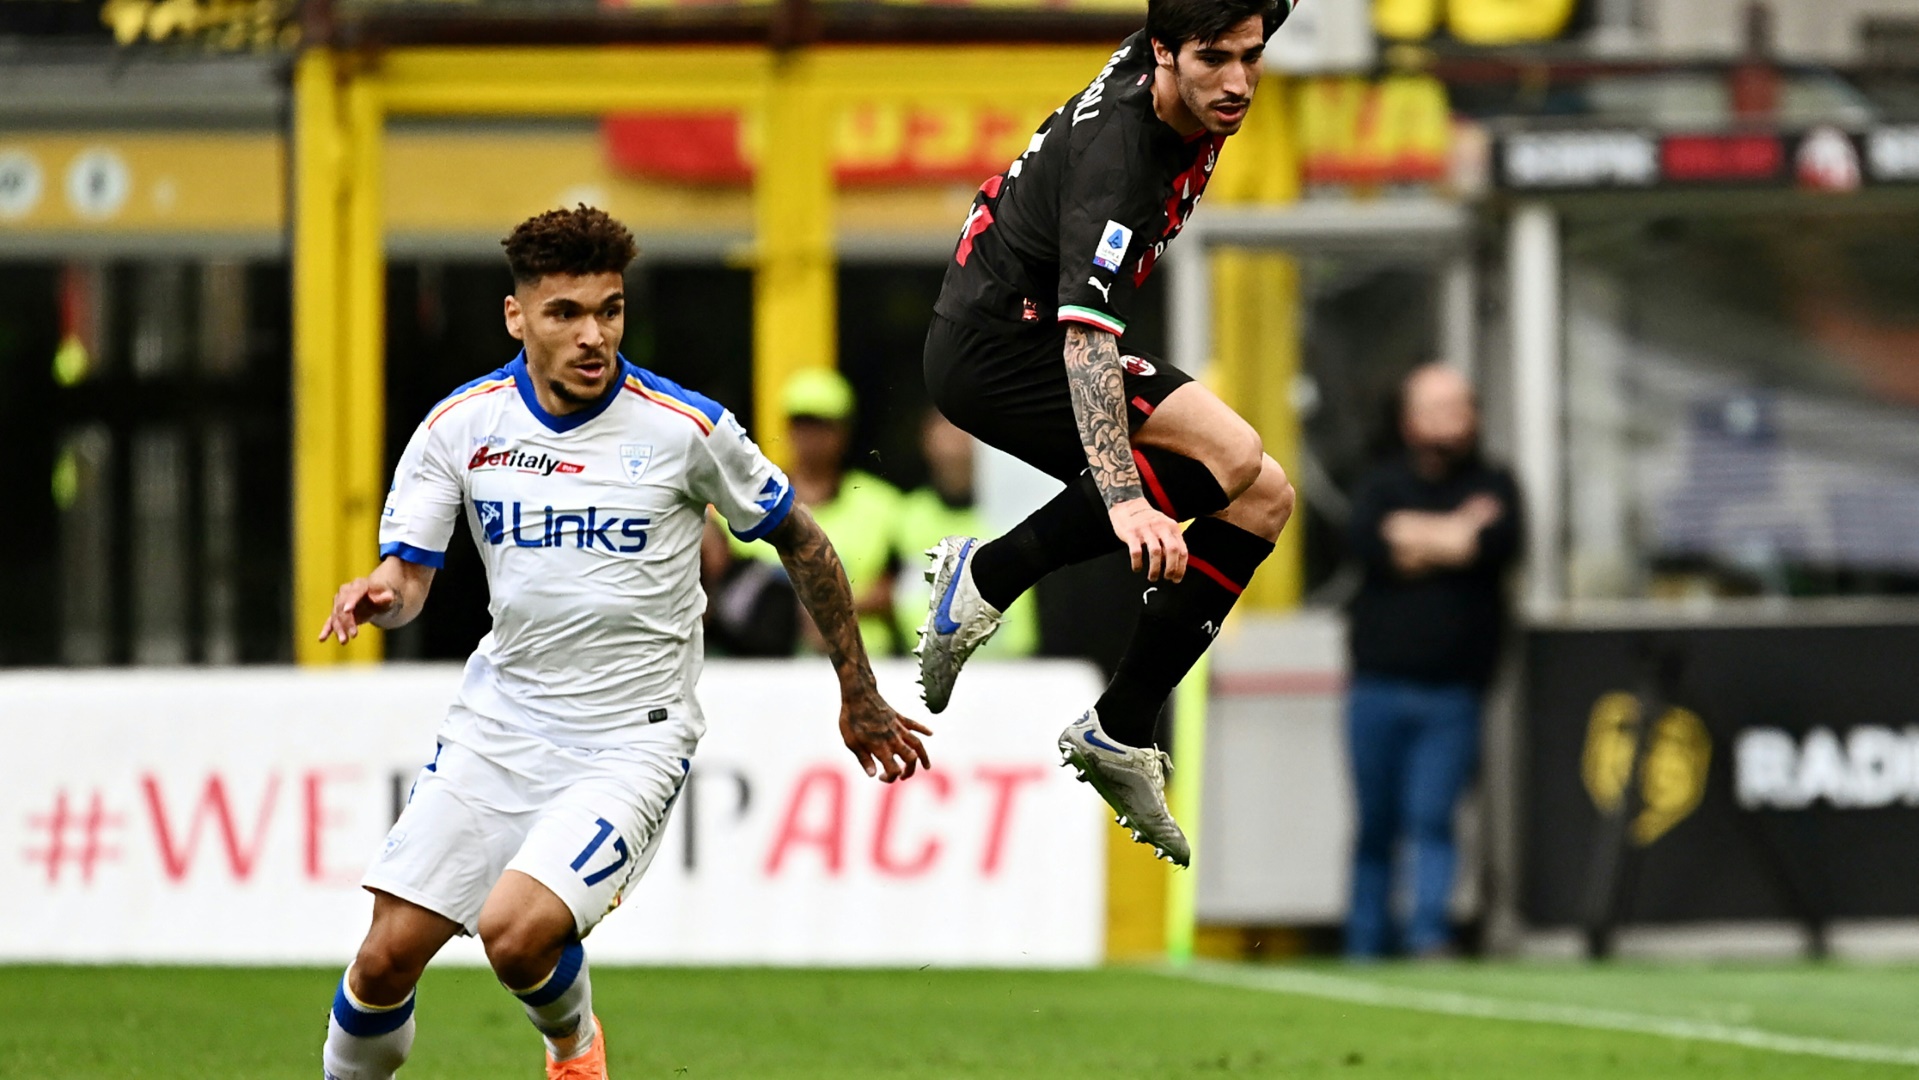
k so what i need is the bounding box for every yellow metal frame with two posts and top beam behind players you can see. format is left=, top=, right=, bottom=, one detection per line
left=294, top=46, right=1105, bottom=664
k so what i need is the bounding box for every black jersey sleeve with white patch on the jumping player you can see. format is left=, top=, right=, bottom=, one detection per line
left=1059, top=125, right=1159, bottom=334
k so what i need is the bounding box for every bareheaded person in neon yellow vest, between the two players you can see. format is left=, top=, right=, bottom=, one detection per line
left=894, top=409, right=1040, bottom=660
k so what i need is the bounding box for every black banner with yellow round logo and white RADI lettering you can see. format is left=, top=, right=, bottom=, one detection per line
left=1524, top=625, right=1919, bottom=927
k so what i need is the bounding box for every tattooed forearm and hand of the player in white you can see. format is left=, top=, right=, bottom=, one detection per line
left=766, top=506, right=933, bottom=781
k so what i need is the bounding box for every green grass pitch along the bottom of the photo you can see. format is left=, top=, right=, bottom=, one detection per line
left=0, top=963, right=1919, bottom=1080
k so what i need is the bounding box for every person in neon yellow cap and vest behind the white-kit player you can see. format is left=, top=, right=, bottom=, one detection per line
left=708, top=368, right=904, bottom=656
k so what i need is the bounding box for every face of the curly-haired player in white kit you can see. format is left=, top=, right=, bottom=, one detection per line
left=507, top=272, right=626, bottom=412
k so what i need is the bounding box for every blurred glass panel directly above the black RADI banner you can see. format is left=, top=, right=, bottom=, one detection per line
left=1566, top=215, right=1919, bottom=599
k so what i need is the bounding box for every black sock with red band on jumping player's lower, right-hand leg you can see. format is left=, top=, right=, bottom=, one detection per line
left=1096, top=518, right=1272, bottom=746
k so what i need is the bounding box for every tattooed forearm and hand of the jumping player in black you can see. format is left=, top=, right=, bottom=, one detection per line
left=1067, top=322, right=1186, bottom=581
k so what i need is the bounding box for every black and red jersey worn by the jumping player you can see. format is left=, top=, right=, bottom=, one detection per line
left=935, top=31, right=1226, bottom=334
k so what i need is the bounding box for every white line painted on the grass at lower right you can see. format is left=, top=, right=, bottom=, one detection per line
left=1159, top=963, right=1919, bottom=1065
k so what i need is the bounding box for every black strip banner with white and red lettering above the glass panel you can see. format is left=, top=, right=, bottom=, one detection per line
left=1497, top=127, right=1919, bottom=194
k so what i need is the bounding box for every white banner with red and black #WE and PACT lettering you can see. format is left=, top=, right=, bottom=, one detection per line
left=0, top=660, right=1105, bottom=967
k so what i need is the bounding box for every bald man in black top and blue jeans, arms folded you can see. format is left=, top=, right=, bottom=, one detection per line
left=1345, top=364, right=1520, bottom=957
